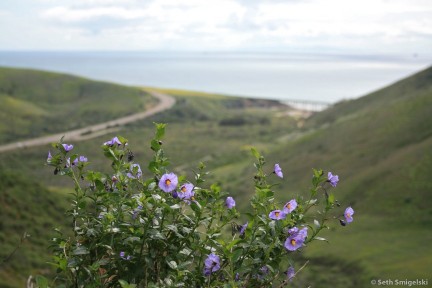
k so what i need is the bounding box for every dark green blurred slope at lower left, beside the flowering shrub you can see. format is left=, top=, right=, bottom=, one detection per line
left=0, top=170, right=68, bottom=288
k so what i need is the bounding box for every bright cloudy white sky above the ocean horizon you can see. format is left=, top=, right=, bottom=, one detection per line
left=0, top=0, right=432, bottom=55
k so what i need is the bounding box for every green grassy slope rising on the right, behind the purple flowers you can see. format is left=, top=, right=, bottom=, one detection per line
left=208, top=68, right=432, bottom=287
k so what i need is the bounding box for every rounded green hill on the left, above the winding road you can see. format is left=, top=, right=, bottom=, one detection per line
left=0, top=67, right=155, bottom=143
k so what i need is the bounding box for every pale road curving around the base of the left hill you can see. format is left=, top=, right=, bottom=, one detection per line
left=0, top=90, right=176, bottom=153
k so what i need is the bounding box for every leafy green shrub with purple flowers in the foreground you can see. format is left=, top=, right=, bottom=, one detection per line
left=47, top=124, right=354, bottom=287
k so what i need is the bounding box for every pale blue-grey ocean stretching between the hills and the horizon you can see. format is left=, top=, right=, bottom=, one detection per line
left=0, top=51, right=432, bottom=103
